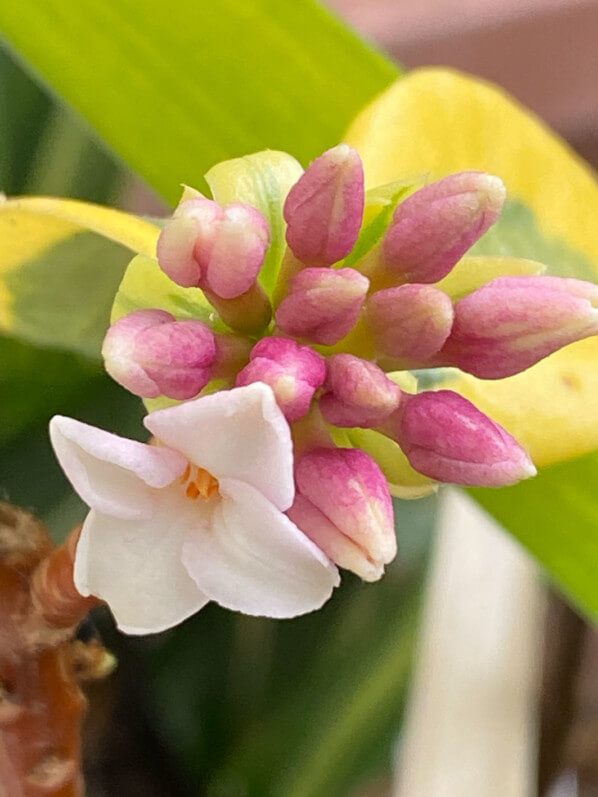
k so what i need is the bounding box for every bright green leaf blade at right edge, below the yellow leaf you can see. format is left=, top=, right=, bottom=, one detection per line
left=471, top=453, right=598, bottom=622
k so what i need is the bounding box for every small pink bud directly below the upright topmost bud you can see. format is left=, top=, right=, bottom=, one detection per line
left=276, top=268, right=370, bottom=346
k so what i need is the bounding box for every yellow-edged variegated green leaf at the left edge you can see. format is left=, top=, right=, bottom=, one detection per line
left=0, top=197, right=159, bottom=359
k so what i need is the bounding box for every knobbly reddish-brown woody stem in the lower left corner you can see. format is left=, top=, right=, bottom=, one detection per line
left=0, top=503, right=108, bottom=797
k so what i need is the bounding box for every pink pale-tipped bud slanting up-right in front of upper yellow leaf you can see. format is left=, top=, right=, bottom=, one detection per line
left=383, top=172, right=506, bottom=282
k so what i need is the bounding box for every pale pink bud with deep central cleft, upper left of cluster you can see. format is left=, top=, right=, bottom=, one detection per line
left=157, top=199, right=270, bottom=299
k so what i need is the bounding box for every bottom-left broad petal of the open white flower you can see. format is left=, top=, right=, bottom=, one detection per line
left=74, top=499, right=208, bottom=634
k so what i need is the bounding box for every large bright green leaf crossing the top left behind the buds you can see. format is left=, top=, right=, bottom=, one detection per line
left=0, top=0, right=397, bottom=202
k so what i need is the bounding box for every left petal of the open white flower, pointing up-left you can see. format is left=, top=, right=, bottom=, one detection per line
left=50, top=415, right=187, bottom=518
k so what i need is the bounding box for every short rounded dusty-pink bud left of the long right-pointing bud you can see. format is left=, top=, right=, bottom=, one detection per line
left=367, top=285, right=453, bottom=362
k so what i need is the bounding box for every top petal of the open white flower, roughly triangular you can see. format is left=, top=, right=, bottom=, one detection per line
left=145, top=382, right=295, bottom=509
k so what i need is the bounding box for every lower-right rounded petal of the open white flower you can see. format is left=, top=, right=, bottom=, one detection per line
left=183, top=479, right=339, bottom=617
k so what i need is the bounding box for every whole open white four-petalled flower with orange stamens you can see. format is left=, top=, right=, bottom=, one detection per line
left=50, top=383, right=339, bottom=634
